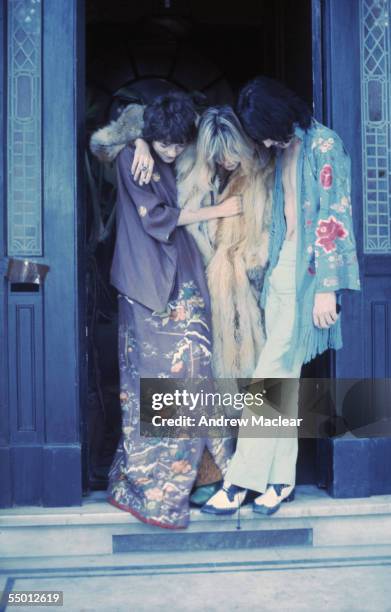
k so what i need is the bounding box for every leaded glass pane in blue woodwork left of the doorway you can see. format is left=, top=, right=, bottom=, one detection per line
left=7, top=0, right=42, bottom=256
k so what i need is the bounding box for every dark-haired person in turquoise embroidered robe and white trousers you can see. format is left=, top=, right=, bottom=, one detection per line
left=202, top=77, right=360, bottom=515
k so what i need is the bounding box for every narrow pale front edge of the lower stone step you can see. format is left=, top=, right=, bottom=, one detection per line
left=0, top=545, right=391, bottom=577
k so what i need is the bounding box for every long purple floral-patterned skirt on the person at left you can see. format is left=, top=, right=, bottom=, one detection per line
left=109, top=281, right=232, bottom=529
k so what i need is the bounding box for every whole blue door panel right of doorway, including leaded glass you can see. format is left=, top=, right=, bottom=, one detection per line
left=315, top=0, right=391, bottom=497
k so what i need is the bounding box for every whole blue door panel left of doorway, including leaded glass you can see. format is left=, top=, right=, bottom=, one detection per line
left=0, top=0, right=83, bottom=506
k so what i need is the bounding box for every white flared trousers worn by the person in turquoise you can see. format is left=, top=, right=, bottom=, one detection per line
left=225, top=241, right=303, bottom=493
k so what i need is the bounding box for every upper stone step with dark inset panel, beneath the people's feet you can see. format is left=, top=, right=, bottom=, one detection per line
left=0, top=486, right=391, bottom=557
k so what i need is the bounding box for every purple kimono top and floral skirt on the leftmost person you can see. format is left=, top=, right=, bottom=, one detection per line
left=108, top=147, right=232, bottom=529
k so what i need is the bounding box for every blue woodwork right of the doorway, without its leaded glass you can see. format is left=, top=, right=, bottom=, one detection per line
left=313, top=0, right=391, bottom=497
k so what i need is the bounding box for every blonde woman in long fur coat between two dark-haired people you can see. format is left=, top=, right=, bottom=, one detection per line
left=177, top=106, right=273, bottom=378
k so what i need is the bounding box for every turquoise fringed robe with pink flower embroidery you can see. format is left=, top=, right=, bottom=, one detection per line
left=261, top=120, right=360, bottom=369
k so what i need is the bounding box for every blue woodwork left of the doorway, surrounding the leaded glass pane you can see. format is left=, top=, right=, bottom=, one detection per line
left=0, top=0, right=85, bottom=506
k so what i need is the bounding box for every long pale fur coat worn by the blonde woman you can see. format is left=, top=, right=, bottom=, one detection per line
left=90, top=105, right=274, bottom=378
